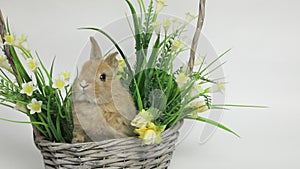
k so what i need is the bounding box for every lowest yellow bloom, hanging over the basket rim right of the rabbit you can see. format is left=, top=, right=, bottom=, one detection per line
left=135, top=122, right=166, bottom=145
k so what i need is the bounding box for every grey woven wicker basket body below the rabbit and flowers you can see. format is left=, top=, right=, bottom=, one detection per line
left=35, top=121, right=183, bottom=169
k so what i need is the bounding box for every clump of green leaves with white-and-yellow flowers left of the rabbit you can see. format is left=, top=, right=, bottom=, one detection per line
left=0, top=21, right=73, bottom=142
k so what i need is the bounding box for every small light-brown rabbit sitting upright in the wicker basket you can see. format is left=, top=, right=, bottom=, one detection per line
left=72, top=37, right=137, bottom=143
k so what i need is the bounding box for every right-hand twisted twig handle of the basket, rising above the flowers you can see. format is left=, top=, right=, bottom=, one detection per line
left=187, top=0, right=206, bottom=73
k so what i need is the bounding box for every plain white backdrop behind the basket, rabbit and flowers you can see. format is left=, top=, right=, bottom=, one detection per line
left=0, top=0, right=300, bottom=169
